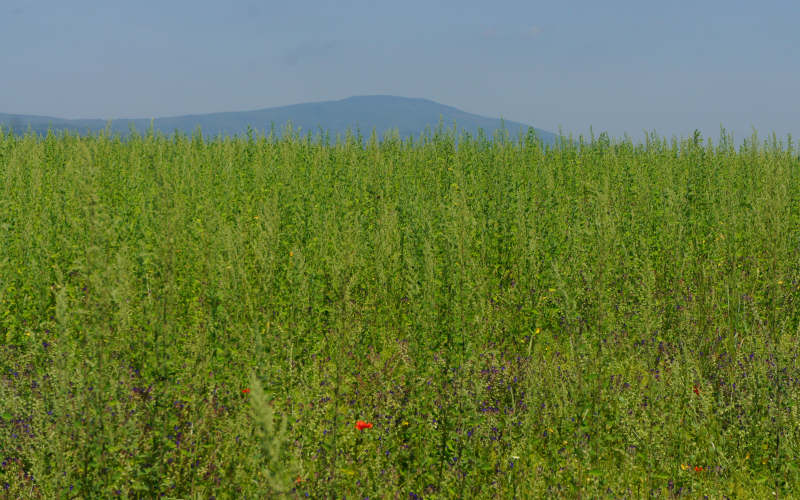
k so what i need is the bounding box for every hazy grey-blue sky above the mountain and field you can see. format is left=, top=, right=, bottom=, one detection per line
left=0, top=0, right=800, bottom=139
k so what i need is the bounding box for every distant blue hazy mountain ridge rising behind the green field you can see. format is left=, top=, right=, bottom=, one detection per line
left=0, top=95, right=555, bottom=143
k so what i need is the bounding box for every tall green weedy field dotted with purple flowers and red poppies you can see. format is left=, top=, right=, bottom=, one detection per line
left=0, top=129, right=800, bottom=500
